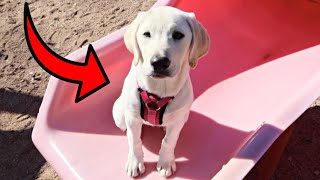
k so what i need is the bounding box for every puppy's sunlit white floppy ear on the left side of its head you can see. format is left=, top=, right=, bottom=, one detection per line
left=124, top=12, right=146, bottom=65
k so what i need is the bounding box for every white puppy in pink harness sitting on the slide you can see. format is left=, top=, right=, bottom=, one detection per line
left=113, top=7, right=209, bottom=177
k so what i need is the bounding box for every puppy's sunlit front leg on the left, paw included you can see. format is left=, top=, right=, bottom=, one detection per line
left=126, top=115, right=145, bottom=177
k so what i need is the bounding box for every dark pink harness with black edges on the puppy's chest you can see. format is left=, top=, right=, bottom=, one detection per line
left=138, top=88, right=174, bottom=125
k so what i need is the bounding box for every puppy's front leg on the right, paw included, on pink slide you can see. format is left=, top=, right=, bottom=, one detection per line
left=157, top=119, right=184, bottom=177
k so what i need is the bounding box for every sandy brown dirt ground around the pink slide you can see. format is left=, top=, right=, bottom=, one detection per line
left=0, top=0, right=320, bottom=180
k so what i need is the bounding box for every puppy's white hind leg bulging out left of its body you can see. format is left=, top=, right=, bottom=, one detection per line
left=112, top=96, right=127, bottom=131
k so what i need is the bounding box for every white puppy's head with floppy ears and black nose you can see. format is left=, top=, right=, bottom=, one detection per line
left=124, top=7, right=209, bottom=78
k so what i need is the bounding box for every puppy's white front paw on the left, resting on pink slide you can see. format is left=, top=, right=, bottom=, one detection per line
left=126, top=157, right=145, bottom=177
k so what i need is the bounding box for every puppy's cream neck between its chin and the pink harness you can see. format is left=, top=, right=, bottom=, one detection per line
left=136, top=62, right=190, bottom=98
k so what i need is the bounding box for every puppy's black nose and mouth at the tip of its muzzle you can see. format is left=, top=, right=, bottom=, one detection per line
left=151, top=57, right=171, bottom=77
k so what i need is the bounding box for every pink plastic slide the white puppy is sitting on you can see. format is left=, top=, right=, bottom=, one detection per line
left=32, top=0, right=320, bottom=180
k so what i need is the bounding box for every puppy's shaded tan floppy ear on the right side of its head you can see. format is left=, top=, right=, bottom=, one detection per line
left=187, top=13, right=210, bottom=68
